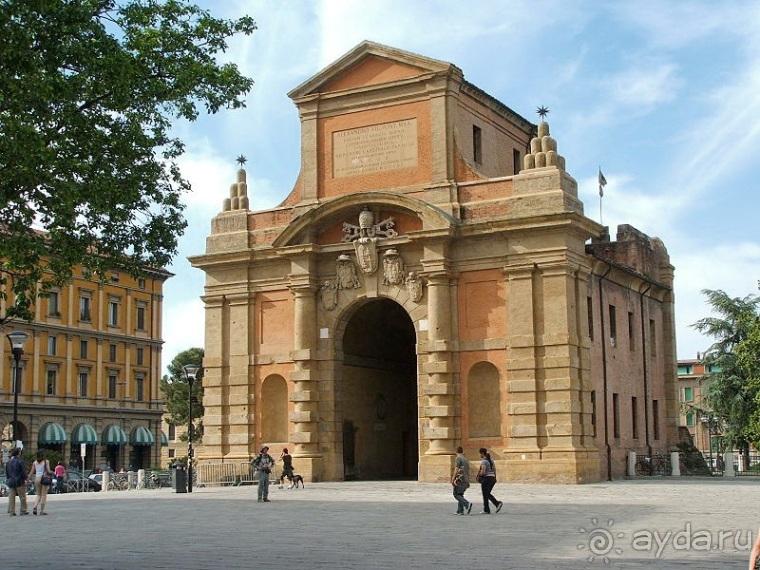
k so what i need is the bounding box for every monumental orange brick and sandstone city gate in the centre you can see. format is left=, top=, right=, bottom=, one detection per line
left=191, top=42, right=678, bottom=483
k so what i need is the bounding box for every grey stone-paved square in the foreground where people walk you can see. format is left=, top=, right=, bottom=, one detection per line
left=0, top=478, right=760, bottom=570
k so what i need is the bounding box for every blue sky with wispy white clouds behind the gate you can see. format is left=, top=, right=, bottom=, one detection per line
left=163, top=0, right=760, bottom=366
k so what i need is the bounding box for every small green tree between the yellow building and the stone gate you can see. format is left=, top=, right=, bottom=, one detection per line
left=159, top=348, right=203, bottom=442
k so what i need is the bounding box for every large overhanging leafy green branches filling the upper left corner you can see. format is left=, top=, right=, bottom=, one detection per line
left=0, top=0, right=256, bottom=324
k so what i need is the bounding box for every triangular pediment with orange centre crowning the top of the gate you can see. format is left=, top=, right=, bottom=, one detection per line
left=288, top=41, right=461, bottom=99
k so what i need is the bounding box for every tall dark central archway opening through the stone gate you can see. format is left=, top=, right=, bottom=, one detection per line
left=340, top=299, right=419, bottom=480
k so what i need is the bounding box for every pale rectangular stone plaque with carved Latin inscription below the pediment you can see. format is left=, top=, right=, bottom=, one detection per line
left=333, top=119, right=417, bottom=178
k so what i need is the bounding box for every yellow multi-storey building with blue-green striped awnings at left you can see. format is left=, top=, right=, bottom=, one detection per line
left=0, top=264, right=171, bottom=469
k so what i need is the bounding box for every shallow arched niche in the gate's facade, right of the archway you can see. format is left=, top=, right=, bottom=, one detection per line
left=467, top=362, right=503, bottom=438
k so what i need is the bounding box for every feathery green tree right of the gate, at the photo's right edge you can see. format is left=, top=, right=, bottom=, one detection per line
left=692, top=289, right=760, bottom=458
